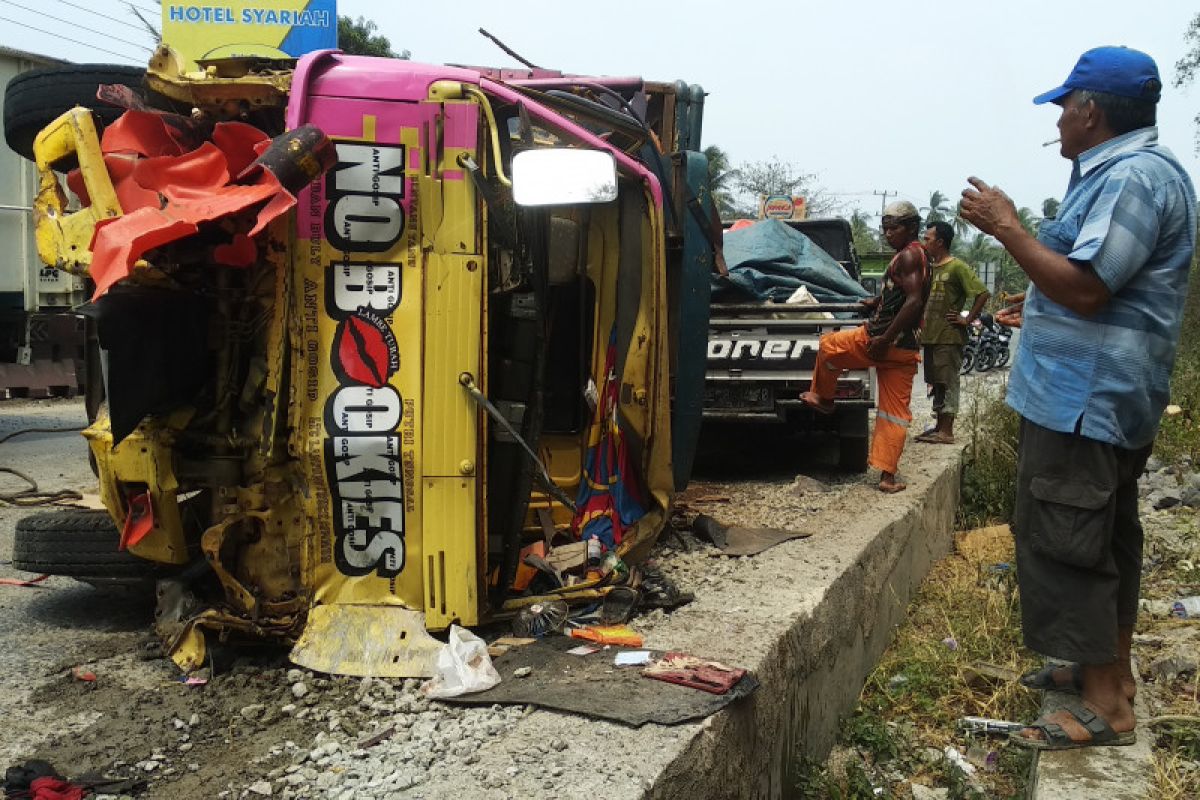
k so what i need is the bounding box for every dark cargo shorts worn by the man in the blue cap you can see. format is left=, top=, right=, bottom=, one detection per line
left=1013, top=419, right=1151, bottom=664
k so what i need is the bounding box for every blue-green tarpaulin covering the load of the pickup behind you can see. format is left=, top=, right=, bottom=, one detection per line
left=713, top=219, right=870, bottom=302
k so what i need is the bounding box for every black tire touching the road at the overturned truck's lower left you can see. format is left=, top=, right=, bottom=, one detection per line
left=12, top=511, right=165, bottom=584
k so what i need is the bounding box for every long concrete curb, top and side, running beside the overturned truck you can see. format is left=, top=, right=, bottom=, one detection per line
left=414, top=441, right=961, bottom=800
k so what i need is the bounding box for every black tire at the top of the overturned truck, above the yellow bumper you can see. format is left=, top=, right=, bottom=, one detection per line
left=4, top=64, right=145, bottom=161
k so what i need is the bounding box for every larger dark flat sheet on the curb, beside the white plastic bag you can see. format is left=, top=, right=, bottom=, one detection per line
left=442, top=636, right=758, bottom=727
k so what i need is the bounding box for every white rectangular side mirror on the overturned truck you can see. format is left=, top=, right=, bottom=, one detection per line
left=512, top=148, right=617, bottom=205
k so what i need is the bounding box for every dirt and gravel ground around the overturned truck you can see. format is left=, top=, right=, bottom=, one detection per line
left=0, top=383, right=945, bottom=800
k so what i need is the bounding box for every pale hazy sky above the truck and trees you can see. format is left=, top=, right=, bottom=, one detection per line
left=0, top=0, right=1200, bottom=220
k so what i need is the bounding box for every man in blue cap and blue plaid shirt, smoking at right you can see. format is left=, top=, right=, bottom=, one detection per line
left=962, top=47, right=1196, bottom=750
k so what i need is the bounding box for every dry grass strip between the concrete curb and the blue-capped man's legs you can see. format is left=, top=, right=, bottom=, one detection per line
left=800, top=528, right=1037, bottom=798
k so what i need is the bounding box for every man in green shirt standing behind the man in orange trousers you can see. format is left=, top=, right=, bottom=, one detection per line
left=917, top=222, right=989, bottom=445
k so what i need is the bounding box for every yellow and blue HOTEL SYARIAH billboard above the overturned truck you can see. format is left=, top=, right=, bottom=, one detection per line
left=162, top=0, right=337, bottom=70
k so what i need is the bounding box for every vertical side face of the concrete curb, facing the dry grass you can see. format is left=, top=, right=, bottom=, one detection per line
left=644, top=445, right=961, bottom=800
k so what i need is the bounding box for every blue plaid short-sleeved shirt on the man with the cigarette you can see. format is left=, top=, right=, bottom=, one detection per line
left=1007, top=127, right=1196, bottom=449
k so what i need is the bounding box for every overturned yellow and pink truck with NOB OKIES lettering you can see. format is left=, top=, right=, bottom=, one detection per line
left=6, top=47, right=720, bottom=676
